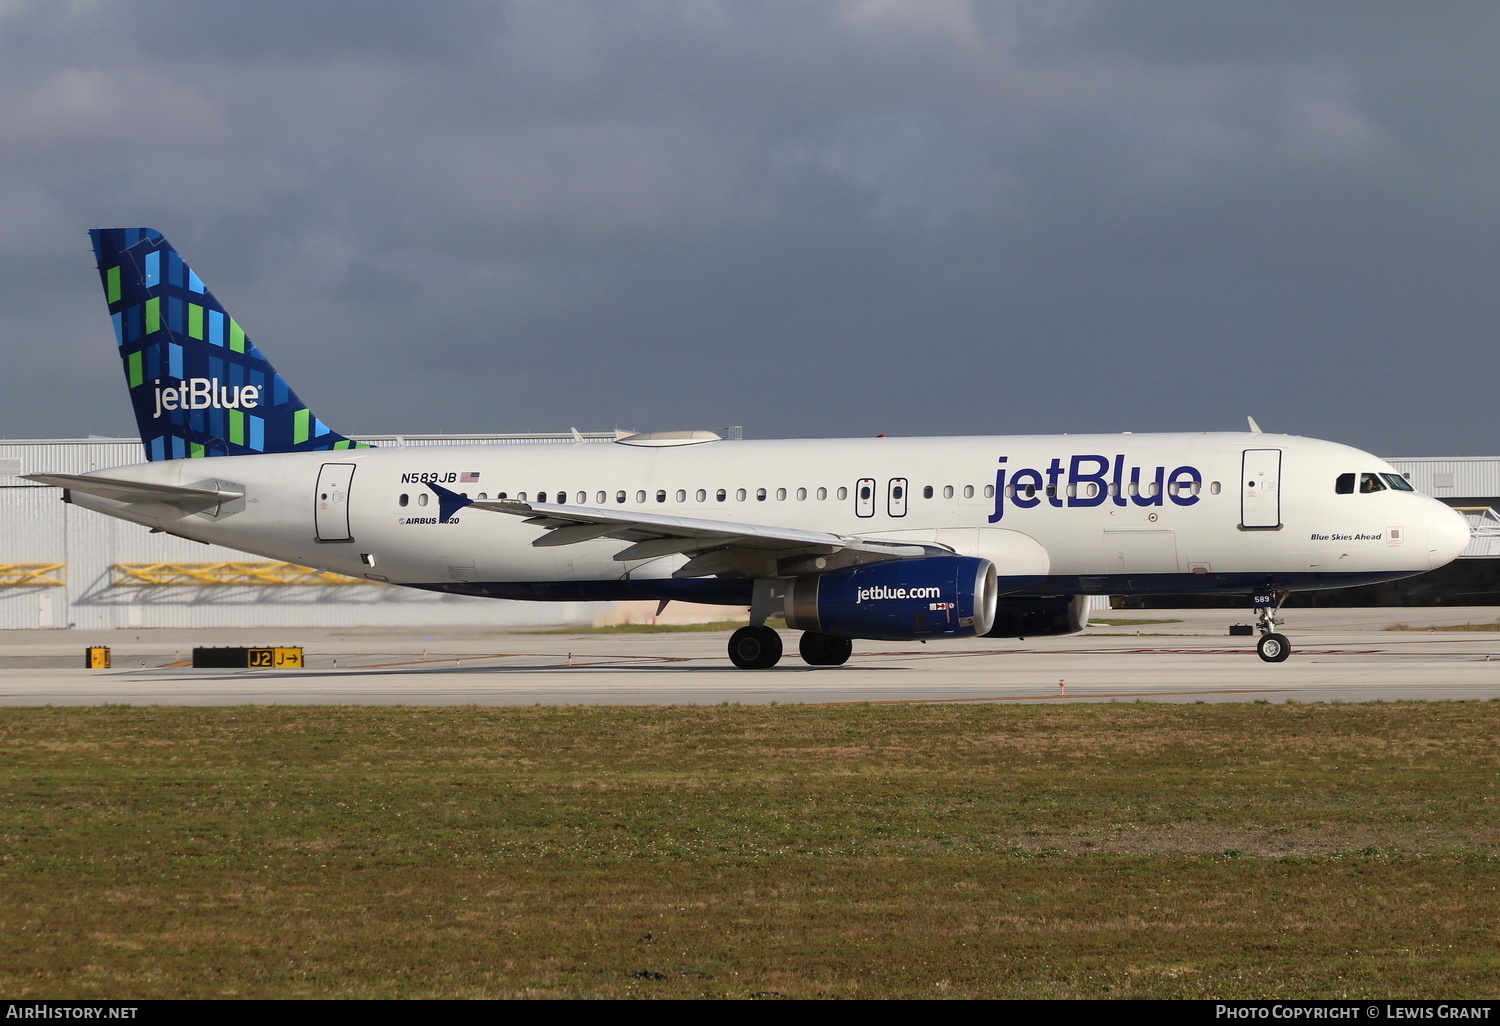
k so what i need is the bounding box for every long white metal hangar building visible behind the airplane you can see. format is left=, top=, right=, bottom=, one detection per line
left=0, top=429, right=1500, bottom=630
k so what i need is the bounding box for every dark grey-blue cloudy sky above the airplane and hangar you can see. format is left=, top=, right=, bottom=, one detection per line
left=0, top=0, right=1500, bottom=456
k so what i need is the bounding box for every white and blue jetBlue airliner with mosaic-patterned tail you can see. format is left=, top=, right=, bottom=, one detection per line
left=27, top=228, right=1470, bottom=669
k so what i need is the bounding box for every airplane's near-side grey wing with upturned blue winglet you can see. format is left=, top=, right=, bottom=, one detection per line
left=429, top=485, right=947, bottom=576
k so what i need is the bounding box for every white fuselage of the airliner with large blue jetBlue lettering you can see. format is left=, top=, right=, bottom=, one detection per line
left=74, top=432, right=1469, bottom=602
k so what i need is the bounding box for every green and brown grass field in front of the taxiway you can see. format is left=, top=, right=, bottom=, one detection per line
left=0, top=702, right=1500, bottom=999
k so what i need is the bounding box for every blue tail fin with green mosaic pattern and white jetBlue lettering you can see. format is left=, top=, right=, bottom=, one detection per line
left=89, top=228, right=366, bottom=461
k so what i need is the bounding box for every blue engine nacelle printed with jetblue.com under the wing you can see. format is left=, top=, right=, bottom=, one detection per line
left=786, top=555, right=996, bottom=641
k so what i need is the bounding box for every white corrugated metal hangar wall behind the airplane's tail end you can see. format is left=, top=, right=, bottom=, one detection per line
left=0, top=435, right=614, bottom=630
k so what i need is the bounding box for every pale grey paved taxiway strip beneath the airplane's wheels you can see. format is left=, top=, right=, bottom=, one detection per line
left=0, top=609, right=1500, bottom=705
